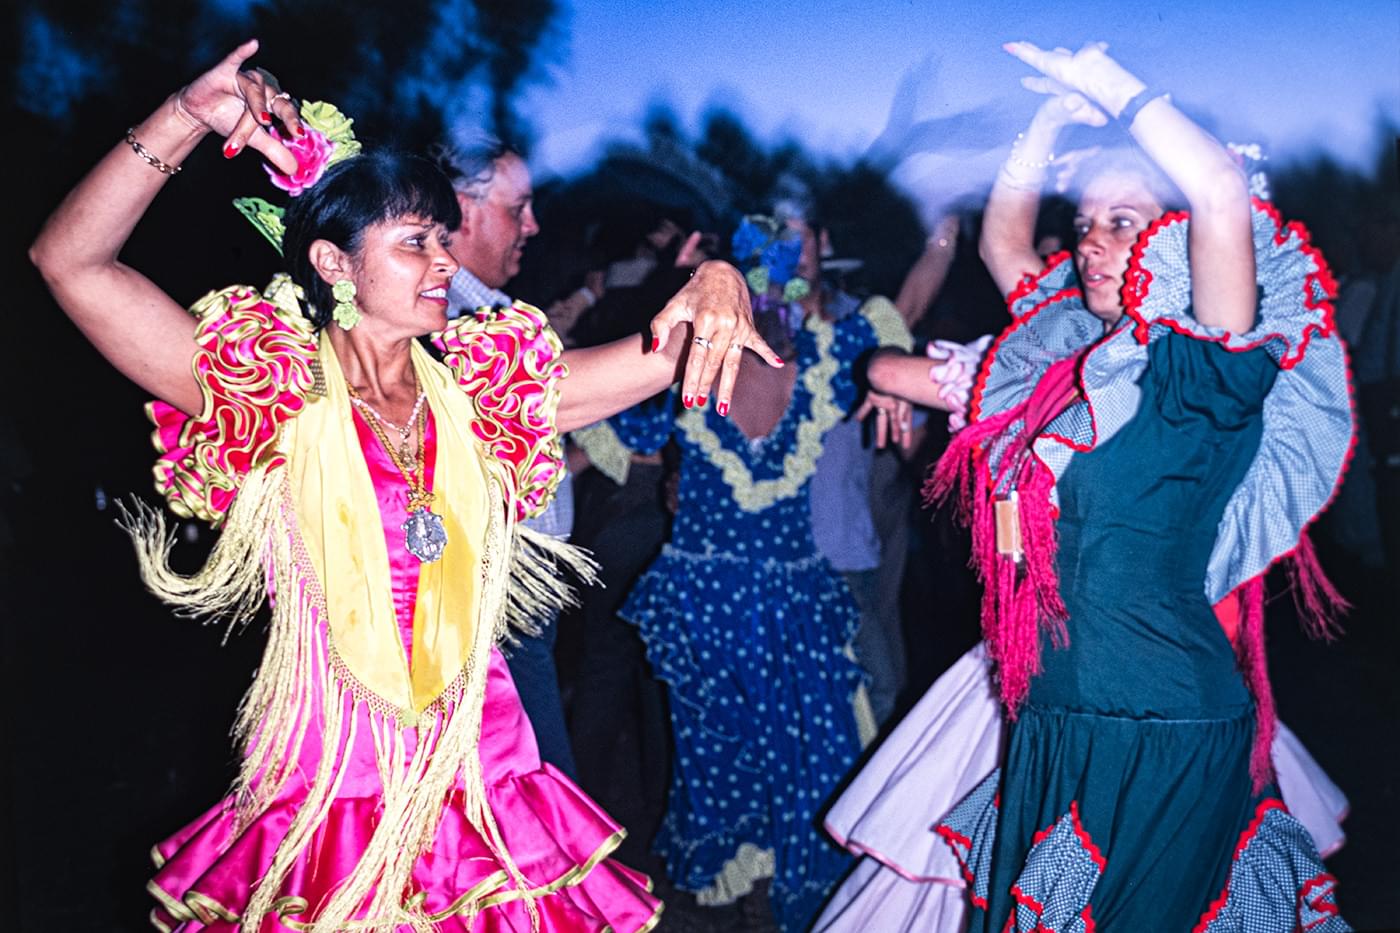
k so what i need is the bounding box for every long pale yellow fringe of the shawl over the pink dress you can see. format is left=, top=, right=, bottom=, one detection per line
left=123, top=456, right=562, bottom=933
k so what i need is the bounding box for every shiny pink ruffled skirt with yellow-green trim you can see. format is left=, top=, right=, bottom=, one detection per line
left=147, top=651, right=661, bottom=933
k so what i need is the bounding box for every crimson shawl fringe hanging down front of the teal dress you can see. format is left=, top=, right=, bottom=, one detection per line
left=924, top=402, right=1068, bottom=719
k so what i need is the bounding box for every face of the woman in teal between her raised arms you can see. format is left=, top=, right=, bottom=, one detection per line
left=1074, top=170, right=1163, bottom=325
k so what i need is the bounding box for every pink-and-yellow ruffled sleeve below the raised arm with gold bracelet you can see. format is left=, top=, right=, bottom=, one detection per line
left=146, top=275, right=316, bottom=525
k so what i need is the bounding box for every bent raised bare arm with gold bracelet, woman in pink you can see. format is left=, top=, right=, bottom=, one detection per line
left=29, top=41, right=301, bottom=415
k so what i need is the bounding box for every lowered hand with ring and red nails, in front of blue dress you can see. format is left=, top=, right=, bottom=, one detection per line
left=651, top=261, right=783, bottom=415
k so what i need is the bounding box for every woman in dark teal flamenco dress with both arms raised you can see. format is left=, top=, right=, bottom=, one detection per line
left=896, top=42, right=1351, bottom=932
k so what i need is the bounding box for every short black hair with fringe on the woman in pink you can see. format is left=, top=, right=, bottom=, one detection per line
left=281, top=150, right=462, bottom=329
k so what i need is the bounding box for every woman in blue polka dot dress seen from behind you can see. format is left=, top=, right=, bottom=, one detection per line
left=599, top=219, right=910, bottom=930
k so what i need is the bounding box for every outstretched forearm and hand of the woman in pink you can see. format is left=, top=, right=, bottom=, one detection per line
left=557, top=261, right=783, bottom=431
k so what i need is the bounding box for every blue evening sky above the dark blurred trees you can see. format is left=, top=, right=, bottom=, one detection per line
left=522, top=0, right=1400, bottom=177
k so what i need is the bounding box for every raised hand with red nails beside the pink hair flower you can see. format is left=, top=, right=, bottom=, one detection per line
left=175, top=39, right=305, bottom=174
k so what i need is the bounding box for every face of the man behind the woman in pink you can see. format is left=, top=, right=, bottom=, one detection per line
left=451, top=154, right=539, bottom=289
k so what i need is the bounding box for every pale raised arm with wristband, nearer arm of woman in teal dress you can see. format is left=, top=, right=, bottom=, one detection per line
left=998, top=42, right=1259, bottom=333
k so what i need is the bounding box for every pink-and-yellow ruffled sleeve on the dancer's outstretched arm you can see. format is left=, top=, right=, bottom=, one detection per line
left=434, top=301, right=568, bottom=518
